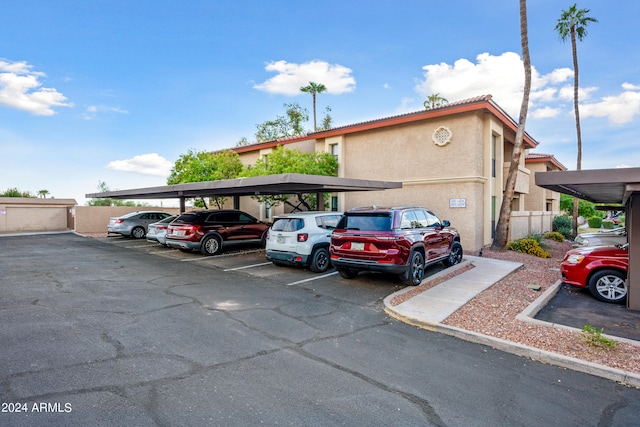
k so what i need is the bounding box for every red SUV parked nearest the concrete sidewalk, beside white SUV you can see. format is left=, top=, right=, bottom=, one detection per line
left=330, top=206, right=462, bottom=285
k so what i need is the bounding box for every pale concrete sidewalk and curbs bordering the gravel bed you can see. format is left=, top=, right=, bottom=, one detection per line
left=384, top=255, right=640, bottom=387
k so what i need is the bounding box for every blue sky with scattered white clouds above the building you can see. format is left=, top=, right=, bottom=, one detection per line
left=0, top=0, right=640, bottom=204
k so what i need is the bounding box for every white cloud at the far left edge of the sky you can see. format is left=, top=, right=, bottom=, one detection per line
left=0, top=59, right=73, bottom=116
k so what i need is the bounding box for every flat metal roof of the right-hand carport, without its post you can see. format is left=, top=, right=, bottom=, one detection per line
left=535, top=168, right=640, bottom=204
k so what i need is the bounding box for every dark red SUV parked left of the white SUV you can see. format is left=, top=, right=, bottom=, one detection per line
left=166, top=210, right=269, bottom=255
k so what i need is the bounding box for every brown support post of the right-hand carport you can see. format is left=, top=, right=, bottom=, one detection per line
left=625, top=193, right=640, bottom=310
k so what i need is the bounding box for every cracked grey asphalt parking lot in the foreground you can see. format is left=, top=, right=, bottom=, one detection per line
left=0, top=233, right=640, bottom=426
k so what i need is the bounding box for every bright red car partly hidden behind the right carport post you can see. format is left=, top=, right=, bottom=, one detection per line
left=560, top=243, right=629, bottom=303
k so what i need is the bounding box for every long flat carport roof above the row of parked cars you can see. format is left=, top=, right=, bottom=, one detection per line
left=85, top=173, right=402, bottom=199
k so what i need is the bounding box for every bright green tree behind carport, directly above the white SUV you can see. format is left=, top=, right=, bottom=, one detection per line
left=242, top=146, right=338, bottom=210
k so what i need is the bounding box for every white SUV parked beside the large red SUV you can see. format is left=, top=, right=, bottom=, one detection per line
left=266, top=212, right=342, bottom=273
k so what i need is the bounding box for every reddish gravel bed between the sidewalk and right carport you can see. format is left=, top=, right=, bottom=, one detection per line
left=442, top=240, right=640, bottom=374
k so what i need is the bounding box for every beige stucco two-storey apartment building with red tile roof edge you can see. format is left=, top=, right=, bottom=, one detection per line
left=234, top=95, right=566, bottom=251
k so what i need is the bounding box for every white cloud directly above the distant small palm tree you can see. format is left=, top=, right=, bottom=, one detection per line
left=253, top=60, right=356, bottom=96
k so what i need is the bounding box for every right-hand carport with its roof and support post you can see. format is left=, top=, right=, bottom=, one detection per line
left=535, top=168, right=640, bottom=310
